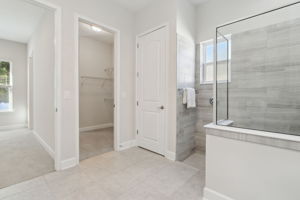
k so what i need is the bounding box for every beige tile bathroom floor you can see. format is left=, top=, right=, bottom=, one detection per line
left=0, top=147, right=204, bottom=200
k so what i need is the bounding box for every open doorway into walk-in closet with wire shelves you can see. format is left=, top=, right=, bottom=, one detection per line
left=77, top=17, right=119, bottom=162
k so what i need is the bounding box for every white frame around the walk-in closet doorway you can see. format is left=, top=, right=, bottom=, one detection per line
left=74, top=14, right=121, bottom=164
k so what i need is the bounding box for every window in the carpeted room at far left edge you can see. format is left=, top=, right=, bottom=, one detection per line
left=0, top=61, right=12, bottom=112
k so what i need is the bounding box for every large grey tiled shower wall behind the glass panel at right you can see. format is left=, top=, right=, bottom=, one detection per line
left=229, top=20, right=300, bottom=135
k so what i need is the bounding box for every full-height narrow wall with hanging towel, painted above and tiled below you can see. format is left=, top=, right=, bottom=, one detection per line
left=176, top=0, right=197, bottom=160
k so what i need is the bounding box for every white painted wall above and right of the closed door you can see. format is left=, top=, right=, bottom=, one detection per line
left=135, top=0, right=177, bottom=153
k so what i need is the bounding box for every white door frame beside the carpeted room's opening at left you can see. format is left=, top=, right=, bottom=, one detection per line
left=25, top=0, right=62, bottom=170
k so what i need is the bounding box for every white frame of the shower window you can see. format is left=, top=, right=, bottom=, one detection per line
left=200, top=35, right=231, bottom=85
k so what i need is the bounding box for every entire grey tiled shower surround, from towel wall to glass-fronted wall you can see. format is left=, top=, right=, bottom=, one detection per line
left=176, top=19, right=300, bottom=160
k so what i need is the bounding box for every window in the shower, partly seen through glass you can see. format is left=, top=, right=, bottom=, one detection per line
left=200, top=37, right=231, bottom=84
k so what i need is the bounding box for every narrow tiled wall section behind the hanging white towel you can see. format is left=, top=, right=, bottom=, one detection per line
left=176, top=35, right=197, bottom=160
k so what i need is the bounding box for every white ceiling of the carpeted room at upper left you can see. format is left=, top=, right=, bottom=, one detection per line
left=0, top=0, right=46, bottom=43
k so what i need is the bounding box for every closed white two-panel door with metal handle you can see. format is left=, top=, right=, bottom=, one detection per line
left=137, top=27, right=167, bottom=155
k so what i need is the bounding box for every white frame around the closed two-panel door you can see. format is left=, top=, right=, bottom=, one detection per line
left=135, top=23, right=170, bottom=157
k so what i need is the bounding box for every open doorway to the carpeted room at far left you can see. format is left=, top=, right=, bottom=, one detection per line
left=0, top=0, right=60, bottom=188
